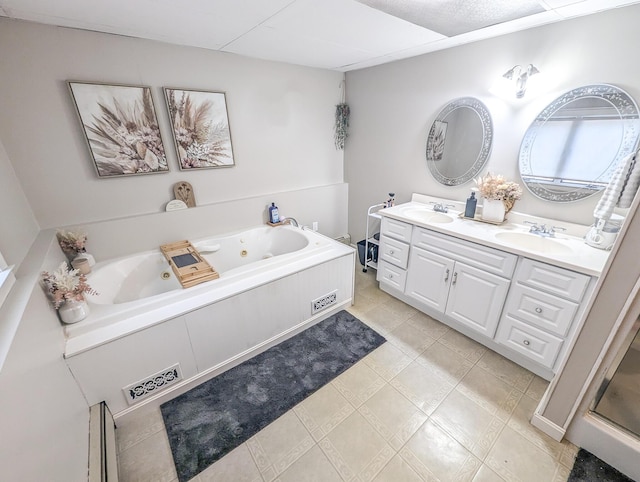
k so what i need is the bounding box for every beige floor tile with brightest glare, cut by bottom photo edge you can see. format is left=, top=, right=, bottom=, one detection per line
left=399, top=420, right=481, bottom=482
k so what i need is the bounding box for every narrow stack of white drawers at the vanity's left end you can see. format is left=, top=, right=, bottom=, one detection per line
left=376, top=218, right=413, bottom=291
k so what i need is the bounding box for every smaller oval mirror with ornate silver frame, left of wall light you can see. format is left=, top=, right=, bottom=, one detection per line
left=427, top=97, right=493, bottom=186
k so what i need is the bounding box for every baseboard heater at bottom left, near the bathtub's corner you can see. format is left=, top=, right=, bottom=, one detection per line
left=89, top=402, right=118, bottom=482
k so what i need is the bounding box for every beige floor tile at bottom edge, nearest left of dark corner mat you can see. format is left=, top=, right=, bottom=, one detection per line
left=485, top=426, right=559, bottom=482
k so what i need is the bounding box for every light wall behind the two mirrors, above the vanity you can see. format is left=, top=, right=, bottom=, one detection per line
left=345, top=5, right=640, bottom=243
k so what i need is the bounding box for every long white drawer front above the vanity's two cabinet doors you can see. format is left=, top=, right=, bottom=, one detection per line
left=411, top=228, right=518, bottom=278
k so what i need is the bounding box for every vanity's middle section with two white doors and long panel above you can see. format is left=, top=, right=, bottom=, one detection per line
left=404, top=227, right=517, bottom=338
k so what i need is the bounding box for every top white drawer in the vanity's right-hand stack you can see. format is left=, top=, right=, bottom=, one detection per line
left=516, top=258, right=591, bottom=302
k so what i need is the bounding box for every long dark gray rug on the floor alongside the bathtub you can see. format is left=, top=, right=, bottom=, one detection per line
left=160, top=311, right=385, bottom=482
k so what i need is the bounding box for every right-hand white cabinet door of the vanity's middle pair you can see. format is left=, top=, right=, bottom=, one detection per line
left=446, top=263, right=509, bottom=338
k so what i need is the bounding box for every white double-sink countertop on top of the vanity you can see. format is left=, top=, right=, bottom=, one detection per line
left=378, top=194, right=610, bottom=277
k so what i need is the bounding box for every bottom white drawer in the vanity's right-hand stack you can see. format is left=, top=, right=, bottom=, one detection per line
left=495, top=316, right=563, bottom=368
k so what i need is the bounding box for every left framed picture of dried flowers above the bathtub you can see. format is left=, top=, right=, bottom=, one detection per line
left=67, top=81, right=169, bottom=178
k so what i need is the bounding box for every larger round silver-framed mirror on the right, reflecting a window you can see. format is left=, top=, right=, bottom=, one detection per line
left=520, top=84, right=640, bottom=202
